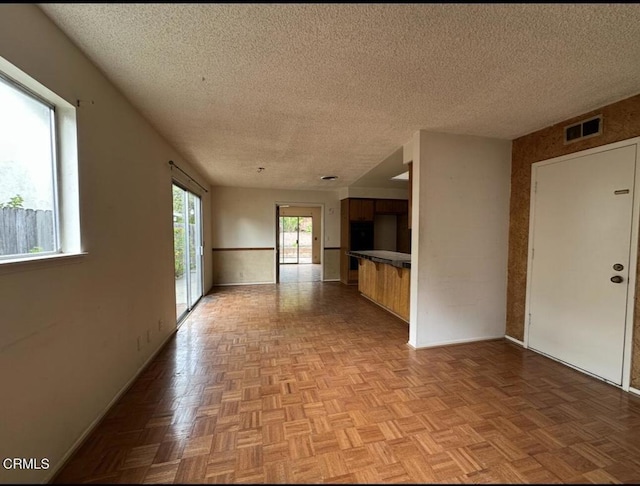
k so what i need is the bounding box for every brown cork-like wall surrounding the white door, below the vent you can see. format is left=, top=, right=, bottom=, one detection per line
left=506, top=95, right=640, bottom=388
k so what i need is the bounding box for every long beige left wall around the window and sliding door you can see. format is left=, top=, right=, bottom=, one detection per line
left=0, top=4, right=211, bottom=483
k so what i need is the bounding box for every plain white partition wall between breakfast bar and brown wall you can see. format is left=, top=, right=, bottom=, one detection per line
left=409, top=131, right=511, bottom=347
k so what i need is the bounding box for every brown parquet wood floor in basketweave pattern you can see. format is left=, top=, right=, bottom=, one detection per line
left=54, top=282, right=640, bottom=483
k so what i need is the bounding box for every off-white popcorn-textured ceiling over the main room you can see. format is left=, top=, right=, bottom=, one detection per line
left=40, top=3, right=640, bottom=189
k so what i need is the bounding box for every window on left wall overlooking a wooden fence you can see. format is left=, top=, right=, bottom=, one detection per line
left=0, top=58, right=80, bottom=264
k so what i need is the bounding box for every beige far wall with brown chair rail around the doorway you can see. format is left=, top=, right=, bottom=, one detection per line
left=207, top=187, right=340, bottom=285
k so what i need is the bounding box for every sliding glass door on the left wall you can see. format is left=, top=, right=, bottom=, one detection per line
left=173, top=184, right=203, bottom=321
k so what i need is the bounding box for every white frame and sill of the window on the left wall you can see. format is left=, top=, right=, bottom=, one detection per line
left=0, top=57, right=85, bottom=275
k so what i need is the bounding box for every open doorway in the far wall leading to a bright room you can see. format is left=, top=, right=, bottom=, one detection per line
left=276, top=204, right=322, bottom=283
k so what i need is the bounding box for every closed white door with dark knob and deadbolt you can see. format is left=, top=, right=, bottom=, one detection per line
left=528, top=145, right=636, bottom=385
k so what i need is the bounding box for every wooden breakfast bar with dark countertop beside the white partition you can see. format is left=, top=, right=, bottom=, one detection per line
left=347, top=250, right=411, bottom=322
